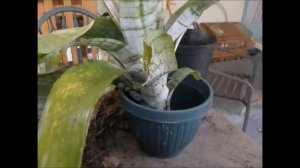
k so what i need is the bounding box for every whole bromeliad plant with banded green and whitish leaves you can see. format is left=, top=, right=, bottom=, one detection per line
left=38, top=0, right=218, bottom=167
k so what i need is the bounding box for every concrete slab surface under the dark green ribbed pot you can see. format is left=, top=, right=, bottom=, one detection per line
left=106, top=111, right=262, bottom=168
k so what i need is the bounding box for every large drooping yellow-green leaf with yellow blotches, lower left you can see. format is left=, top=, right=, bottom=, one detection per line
left=38, top=61, right=122, bottom=167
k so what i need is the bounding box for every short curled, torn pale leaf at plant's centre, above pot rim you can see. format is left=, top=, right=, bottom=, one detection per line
left=141, top=30, right=177, bottom=109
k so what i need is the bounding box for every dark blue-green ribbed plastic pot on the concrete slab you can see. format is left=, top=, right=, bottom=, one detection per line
left=120, top=76, right=213, bottom=158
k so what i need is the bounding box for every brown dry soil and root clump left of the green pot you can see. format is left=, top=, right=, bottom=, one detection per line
left=81, top=91, right=129, bottom=168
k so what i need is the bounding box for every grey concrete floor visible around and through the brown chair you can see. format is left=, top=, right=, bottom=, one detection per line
left=211, top=53, right=262, bottom=145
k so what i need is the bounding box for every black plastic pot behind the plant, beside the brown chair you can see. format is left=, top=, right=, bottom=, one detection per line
left=176, top=29, right=217, bottom=79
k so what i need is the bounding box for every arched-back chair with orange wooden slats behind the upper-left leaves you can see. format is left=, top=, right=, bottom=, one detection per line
left=38, top=6, right=97, bottom=66
